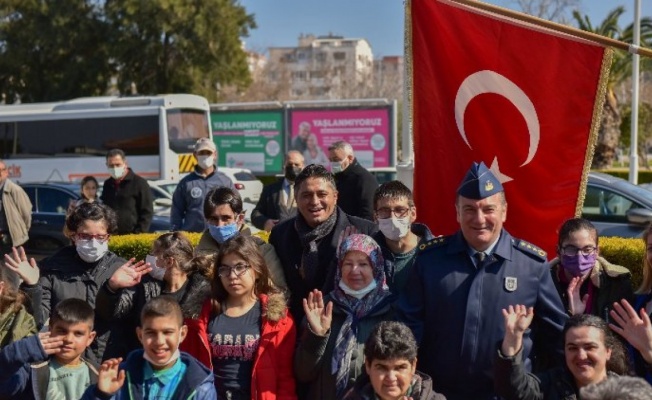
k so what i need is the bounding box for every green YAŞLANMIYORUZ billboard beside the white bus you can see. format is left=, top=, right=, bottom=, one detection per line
left=211, top=110, right=285, bottom=175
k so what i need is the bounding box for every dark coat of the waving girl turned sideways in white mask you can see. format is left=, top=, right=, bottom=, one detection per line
left=96, top=272, right=211, bottom=359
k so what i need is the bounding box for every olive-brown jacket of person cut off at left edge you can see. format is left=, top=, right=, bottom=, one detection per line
left=0, top=267, right=37, bottom=349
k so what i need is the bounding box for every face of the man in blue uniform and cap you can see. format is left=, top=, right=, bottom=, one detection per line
left=455, top=193, right=507, bottom=251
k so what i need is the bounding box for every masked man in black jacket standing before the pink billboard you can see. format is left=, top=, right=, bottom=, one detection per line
left=328, top=141, right=378, bottom=221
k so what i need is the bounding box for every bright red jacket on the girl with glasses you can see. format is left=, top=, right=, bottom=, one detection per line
left=183, top=294, right=297, bottom=400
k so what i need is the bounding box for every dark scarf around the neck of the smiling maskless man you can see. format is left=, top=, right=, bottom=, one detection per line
left=294, top=208, right=339, bottom=287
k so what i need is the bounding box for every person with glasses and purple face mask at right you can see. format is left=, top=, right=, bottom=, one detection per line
left=550, top=218, right=633, bottom=320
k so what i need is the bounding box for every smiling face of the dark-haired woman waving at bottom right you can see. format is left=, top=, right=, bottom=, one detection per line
left=564, top=326, right=611, bottom=387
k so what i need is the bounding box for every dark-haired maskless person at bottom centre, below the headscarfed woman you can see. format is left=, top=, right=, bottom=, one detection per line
left=344, top=321, right=446, bottom=400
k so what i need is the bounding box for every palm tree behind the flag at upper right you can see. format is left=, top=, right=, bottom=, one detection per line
left=573, top=6, right=652, bottom=168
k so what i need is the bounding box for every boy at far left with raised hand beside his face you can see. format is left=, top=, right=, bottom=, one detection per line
left=0, top=299, right=98, bottom=400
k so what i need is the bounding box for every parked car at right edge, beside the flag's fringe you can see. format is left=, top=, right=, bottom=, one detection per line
left=582, top=172, right=652, bottom=237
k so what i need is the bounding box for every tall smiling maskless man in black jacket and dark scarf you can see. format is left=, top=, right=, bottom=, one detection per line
left=269, top=164, right=377, bottom=321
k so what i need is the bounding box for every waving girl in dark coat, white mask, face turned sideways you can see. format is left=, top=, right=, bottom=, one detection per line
left=96, top=232, right=213, bottom=358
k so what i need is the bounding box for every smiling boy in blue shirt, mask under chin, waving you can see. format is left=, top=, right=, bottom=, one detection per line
left=82, top=296, right=217, bottom=400
